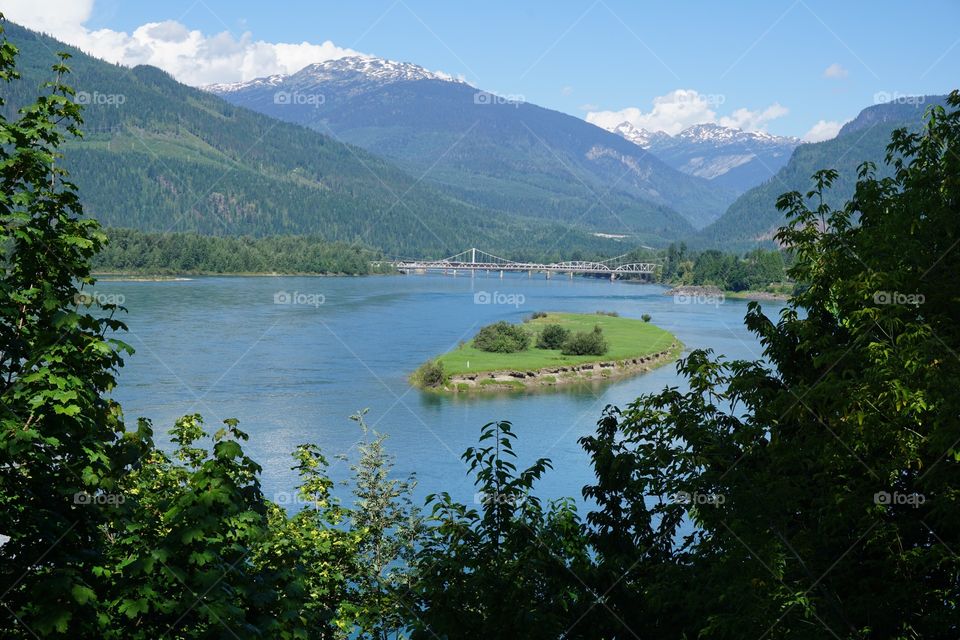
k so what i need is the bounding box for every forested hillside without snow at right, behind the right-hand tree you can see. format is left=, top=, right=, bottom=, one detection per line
left=696, top=96, right=946, bottom=249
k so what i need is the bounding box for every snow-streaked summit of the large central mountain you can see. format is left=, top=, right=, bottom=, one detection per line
left=204, top=56, right=465, bottom=94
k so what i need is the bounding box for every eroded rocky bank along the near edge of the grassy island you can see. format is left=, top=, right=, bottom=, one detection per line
left=444, top=342, right=683, bottom=393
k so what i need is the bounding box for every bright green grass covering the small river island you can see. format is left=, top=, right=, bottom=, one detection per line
left=437, top=313, right=676, bottom=375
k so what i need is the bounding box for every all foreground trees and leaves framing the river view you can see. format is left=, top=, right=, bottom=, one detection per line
left=0, top=17, right=960, bottom=640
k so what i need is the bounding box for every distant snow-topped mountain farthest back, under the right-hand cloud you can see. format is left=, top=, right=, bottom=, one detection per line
left=611, top=122, right=800, bottom=193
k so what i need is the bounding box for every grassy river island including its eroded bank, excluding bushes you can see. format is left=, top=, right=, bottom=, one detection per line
left=411, top=313, right=683, bottom=393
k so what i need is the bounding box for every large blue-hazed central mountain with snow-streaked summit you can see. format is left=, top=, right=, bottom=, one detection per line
left=207, top=57, right=735, bottom=229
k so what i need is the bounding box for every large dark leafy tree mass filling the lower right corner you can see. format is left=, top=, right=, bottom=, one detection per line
left=584, top=92, right=960, bottom=640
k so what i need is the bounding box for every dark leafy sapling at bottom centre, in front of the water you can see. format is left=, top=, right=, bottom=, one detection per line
left=411, top=422, right=589, bottom=638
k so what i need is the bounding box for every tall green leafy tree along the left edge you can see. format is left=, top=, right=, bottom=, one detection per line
left=0, top=23, right=140, bottom=637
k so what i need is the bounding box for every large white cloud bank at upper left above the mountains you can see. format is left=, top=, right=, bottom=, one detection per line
left=3, top=0, right=364, bottom=85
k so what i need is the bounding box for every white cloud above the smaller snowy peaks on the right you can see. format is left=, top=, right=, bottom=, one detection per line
left=586, top=89, right=789, bottom=135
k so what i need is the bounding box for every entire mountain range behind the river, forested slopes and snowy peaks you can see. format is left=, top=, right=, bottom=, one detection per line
left=0, top=23, right=944, bottom=259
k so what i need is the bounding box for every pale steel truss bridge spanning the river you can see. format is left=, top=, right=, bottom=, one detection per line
left=390, top=247, right=658, bottom=280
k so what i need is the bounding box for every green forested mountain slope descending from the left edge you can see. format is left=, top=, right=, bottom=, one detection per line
left=3, top=22, right=644, bottom=257
